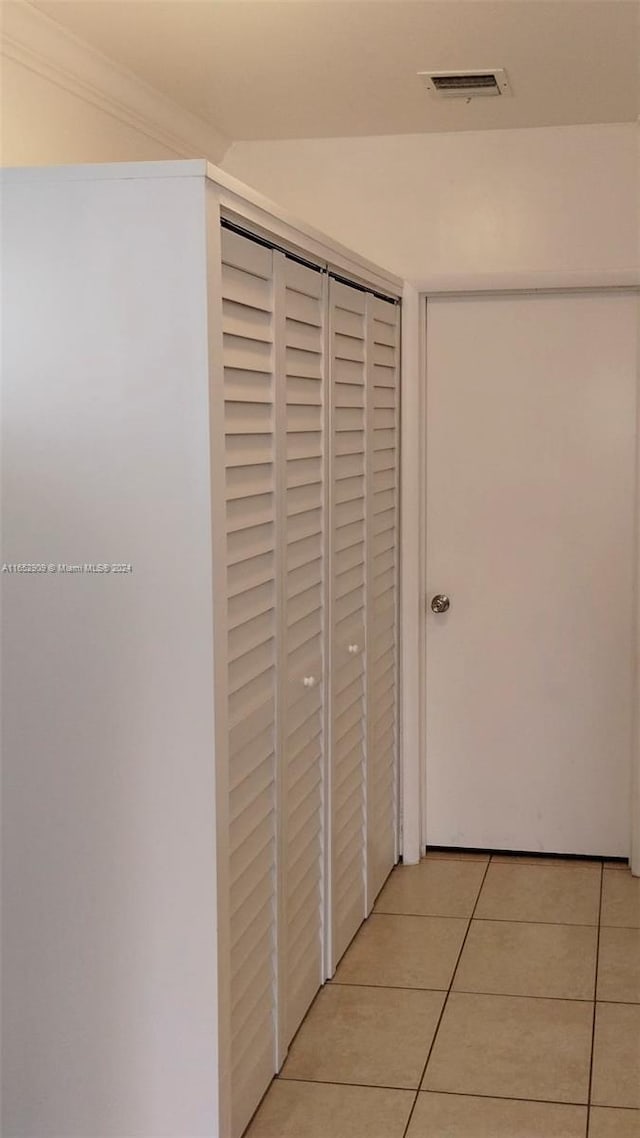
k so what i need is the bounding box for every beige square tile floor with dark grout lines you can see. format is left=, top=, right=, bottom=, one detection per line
left=241, top=852, right=640, bottom=1138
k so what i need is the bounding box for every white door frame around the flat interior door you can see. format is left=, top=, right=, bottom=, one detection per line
left=400, top=279, right=640, bottom=876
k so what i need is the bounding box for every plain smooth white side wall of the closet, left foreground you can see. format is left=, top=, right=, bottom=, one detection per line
left=0, top=167, right=218, bottom=1138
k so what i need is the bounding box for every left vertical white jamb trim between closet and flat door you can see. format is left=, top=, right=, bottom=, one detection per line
left=400, top=285, right=425, bottom=865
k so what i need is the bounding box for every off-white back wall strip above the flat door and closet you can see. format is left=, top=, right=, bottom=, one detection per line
left=223, top=124, right=640, bottom=287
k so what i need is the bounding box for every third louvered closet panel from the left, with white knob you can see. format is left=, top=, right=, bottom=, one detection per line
left=329, top=280, right=367, bottom=967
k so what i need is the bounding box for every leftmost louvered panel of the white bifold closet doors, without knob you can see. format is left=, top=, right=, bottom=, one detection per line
left=220, top=230, right=277, bottom=1138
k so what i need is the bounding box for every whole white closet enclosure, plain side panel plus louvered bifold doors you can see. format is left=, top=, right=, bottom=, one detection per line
left=3, top=163, right=400, bottom=1138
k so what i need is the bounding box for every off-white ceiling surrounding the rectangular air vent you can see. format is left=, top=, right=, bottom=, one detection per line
left=34, top=0, right=640, bottom=140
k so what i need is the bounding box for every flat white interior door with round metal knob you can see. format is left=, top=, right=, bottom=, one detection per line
left=426, top=292, right=638, bottom=856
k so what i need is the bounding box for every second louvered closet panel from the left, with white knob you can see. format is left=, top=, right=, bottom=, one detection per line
left=276, top=253, right=327, bottom=1058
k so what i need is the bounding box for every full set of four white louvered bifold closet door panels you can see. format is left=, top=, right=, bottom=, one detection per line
left=222, top=229, right=399, bottom=1124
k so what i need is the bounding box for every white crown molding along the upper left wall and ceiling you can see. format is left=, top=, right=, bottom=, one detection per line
left=0, top=0, right=230, bottom=163
